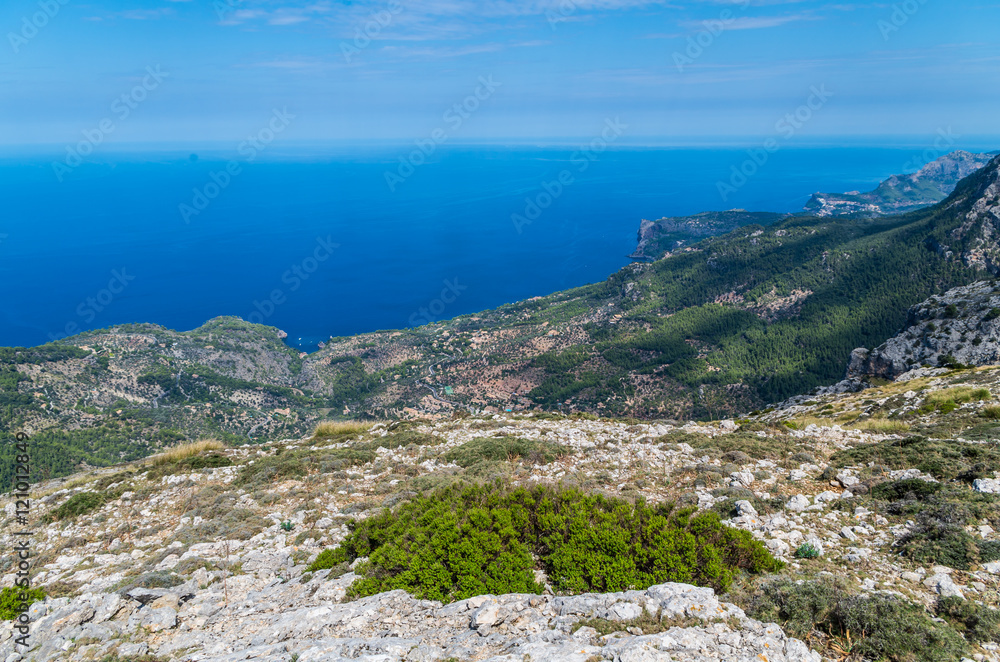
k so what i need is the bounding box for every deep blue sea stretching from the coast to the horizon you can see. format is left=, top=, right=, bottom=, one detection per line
left=0, top=139, right=996, bottom=351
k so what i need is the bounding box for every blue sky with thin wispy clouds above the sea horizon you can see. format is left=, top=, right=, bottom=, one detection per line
left=0, top=0, right=1000, bottom=146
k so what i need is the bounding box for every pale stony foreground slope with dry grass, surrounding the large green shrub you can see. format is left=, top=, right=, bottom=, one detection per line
left=9, top=360, right=1000, bottom=662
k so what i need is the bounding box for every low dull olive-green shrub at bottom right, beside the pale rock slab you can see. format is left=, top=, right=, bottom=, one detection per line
left=742, top=579, right=966, bottom=662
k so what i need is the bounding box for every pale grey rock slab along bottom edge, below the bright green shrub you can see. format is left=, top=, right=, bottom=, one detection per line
left=0, top=571, right=821, bottom=662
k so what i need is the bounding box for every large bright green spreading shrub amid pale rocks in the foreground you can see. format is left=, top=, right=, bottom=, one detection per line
left=309, top=483, right=783, bottom=602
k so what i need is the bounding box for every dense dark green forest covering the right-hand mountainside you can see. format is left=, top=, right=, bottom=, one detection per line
left=496, top=169, right=996, bottom=418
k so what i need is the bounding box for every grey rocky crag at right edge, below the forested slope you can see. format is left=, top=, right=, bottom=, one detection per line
left=847, top=282, right=1000, bottom=379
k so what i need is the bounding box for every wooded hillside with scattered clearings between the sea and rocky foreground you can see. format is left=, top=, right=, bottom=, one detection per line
left=0, top=153, right=1000, bottom=488
